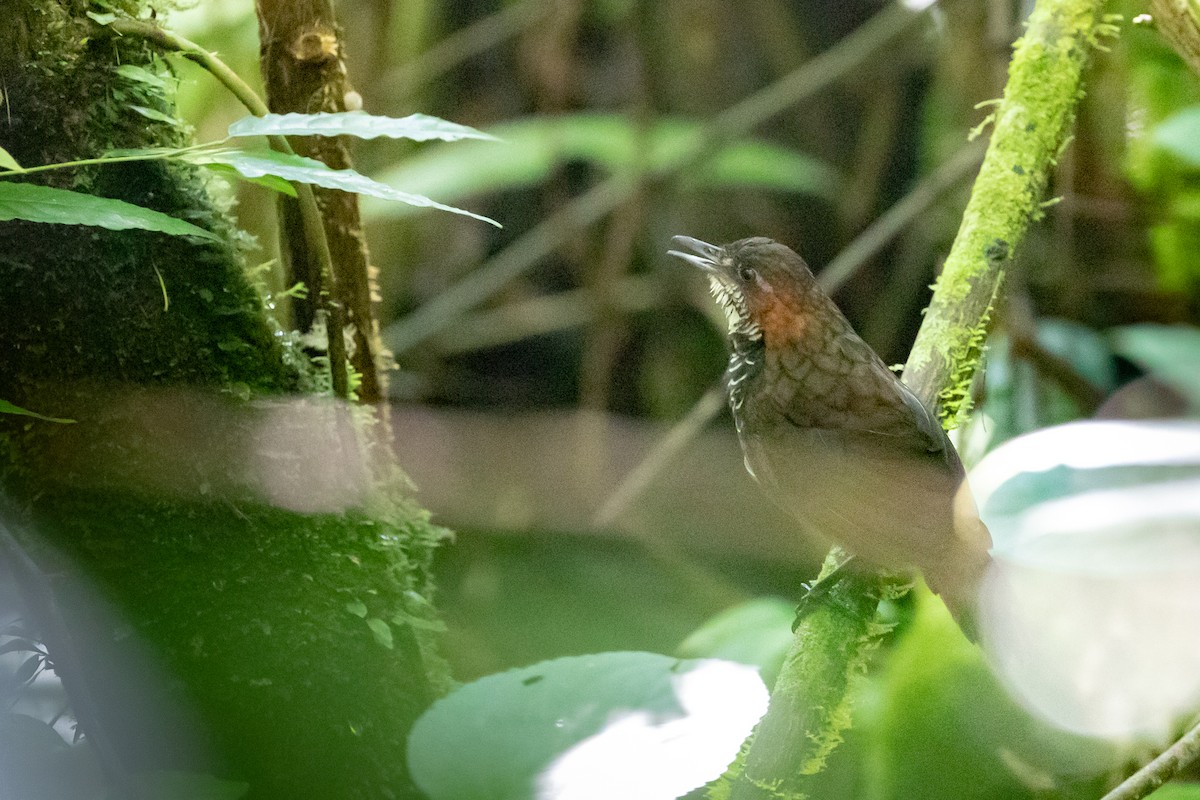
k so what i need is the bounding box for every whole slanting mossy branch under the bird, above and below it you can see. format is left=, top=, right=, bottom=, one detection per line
left=710, top=0, right=1112, bottom=800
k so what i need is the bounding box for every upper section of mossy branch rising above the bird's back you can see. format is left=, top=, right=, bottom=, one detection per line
left=904, top=0, right=1114, bottom=421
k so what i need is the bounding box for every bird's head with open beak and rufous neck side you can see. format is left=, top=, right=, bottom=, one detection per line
left=670, top=236, right=818, bottom=344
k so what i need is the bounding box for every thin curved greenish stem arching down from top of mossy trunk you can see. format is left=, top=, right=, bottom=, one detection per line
left=107, top=19, right=350, bottom=398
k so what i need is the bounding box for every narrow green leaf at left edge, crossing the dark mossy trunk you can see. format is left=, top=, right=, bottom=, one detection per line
left=0, top=181, right=221, bottom=241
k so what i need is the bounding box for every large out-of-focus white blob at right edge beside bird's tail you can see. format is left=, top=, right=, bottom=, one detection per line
left=971, top=421, right=1200, bottom=740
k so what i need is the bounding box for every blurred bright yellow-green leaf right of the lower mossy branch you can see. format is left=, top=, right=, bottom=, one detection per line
left=868, top=591, right=1120, bottom=800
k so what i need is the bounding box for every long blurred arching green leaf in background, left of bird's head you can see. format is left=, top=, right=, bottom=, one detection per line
left=364, top=114, right=838, bottom=217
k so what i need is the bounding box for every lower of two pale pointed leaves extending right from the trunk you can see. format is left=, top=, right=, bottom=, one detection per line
left=181, top=150, right=500, bottom=228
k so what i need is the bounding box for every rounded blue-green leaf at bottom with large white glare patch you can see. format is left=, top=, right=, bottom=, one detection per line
left=408, top=652, right=767, bottom=800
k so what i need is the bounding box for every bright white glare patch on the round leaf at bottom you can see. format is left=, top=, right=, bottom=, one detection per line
left=535, top=660, right=768, bottom=800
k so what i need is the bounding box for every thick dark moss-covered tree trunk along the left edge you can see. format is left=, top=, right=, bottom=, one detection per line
left=0, top=0, right=442, bottom=798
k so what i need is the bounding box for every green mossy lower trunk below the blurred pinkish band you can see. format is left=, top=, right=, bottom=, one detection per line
left=34, top=489, right=446, bottom=798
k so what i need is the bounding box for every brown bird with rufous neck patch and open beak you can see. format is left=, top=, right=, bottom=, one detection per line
left=668, top=236, right=991, bottom=618
